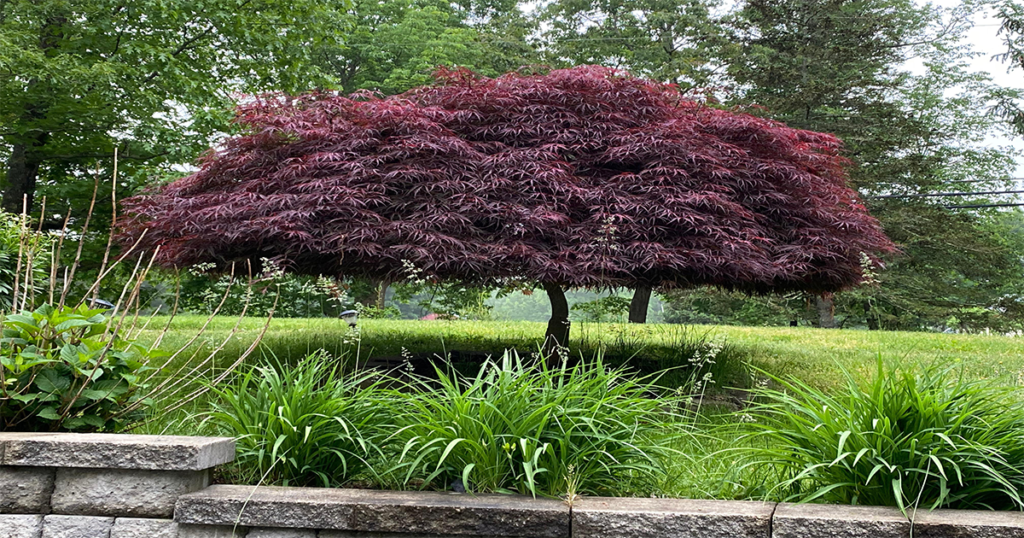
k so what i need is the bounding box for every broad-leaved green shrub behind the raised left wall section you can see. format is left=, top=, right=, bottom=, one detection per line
left=0, top=304, right=162, bottom=431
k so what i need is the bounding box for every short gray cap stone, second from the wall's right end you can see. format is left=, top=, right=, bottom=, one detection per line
left=771, top=503, right=910, bottom=538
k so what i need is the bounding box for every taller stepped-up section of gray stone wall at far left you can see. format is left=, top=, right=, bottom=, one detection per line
left=0, top=432, right=234, bottom=538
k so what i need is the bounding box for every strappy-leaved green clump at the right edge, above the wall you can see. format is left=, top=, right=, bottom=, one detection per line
left=735, top=358, right=1024, bottom=511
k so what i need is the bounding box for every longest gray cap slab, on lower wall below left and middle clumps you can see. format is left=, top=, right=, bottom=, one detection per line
left=174, top=485, right=569, bottom=538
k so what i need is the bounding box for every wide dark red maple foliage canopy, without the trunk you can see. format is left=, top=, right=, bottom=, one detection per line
left=124, top=67, right=892, bottom=338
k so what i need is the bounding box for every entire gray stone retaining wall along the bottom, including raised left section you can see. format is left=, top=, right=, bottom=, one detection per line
left=0, top=432, right=1024, bottom=538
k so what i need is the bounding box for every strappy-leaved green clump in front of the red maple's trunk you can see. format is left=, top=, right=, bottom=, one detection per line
left=394, top=353, right=682, bottom=496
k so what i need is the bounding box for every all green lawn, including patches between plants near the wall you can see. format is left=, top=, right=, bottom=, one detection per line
left=139, top=317, right=1024, bottom=498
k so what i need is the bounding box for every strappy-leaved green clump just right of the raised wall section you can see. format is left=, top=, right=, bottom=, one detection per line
left=210, top=353, right=393, bottom=487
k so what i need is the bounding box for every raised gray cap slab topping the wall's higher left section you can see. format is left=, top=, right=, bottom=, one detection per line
left=0, top=432, right=234, bottom=470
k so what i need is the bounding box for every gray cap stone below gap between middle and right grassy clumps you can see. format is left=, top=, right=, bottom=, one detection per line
left=572, top=497, right=775, bottom=538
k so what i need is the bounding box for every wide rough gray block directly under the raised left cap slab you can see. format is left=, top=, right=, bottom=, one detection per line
left=50, top=468, right=210, bottom=518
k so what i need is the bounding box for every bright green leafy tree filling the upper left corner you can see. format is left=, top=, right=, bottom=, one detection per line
left=0, top=0, right=345, bottom=212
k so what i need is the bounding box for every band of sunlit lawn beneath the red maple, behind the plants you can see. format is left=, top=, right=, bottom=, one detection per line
left=136, top=317, right=1024, bottom=388
